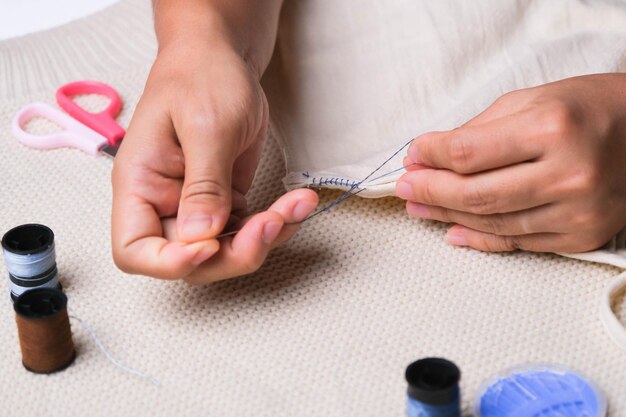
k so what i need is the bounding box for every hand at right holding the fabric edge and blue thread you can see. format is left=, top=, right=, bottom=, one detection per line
left=396, top=73, right=626, bottom=252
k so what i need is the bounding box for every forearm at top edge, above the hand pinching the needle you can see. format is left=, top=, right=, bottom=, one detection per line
left=153, top=0, right=283, bottom=77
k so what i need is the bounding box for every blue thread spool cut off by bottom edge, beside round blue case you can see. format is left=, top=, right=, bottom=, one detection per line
left=405, top=358, right=461, bottom=417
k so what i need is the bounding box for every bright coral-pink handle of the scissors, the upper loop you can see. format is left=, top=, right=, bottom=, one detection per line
left=56, top=81, right=126, bottom=146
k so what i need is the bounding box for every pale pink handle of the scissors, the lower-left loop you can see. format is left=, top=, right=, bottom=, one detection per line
left=11, top=102, right=108, bottom=155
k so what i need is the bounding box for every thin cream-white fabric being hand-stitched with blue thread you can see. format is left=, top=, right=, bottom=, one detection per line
left=266, top=0, right=626, bottom=268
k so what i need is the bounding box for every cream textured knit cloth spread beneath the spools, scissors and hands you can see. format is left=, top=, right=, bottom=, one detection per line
left=0, top=0, right=626, bottom=417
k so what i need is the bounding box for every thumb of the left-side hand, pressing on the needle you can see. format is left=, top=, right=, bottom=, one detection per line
left=176, top=118, right=237, bottom=242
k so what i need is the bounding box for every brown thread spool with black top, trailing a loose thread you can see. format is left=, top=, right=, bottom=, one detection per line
left=13, top=288, right=76, bottom=374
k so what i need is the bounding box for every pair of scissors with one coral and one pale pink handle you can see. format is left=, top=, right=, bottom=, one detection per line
left=12, top=81, right=126, bottom=157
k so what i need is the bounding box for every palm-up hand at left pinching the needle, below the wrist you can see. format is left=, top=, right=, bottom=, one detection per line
left=112, top=43, right=317, bottom=283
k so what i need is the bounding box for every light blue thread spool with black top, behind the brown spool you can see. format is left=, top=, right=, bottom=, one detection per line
left=2, top=224, right=61, bottom=301
